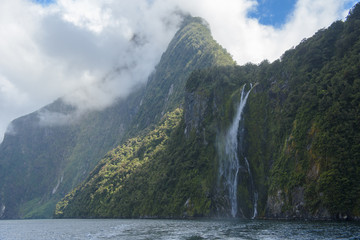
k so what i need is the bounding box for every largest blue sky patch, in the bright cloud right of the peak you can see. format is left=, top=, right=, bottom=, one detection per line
left=248, top=0, right=297, bottom=27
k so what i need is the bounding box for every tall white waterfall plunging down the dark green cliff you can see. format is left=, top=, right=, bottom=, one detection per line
left=219, top=84, right=257, bottom=218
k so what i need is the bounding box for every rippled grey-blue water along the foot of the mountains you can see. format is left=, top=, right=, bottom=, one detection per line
left=0, top=219, right=360, bottom=240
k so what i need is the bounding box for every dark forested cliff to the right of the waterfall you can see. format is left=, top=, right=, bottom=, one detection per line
left=247, top=4, right=360, bottom=219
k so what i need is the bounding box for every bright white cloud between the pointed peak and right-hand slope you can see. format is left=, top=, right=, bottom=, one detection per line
left=164, top=0, right=354, bottom=64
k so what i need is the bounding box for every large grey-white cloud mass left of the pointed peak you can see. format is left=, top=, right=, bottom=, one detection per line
left=0, top=0, right=179, bottom=142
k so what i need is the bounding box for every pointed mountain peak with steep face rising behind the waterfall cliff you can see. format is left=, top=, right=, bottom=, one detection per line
left=131, top=17, right=235, bottom=137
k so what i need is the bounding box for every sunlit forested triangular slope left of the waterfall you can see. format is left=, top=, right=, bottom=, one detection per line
left=55, top=109, right=214, bottom=217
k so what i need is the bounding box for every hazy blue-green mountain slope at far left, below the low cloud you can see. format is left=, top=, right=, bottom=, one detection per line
left=0, top=88, right=141, bottom=218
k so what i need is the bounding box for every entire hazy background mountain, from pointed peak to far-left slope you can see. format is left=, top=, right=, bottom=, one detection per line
left=0, top=17, right=235, bottom=219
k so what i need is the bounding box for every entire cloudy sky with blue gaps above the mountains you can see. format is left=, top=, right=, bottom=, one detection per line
left=0, top=0, right=358, bottom=142
